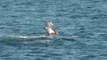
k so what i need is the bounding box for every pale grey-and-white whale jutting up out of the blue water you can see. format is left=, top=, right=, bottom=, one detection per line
left=45, top=20, right=58, bottom=35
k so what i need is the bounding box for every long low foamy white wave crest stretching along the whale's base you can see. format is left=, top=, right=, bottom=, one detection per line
left=0, top=35, right=78, bottom=40
